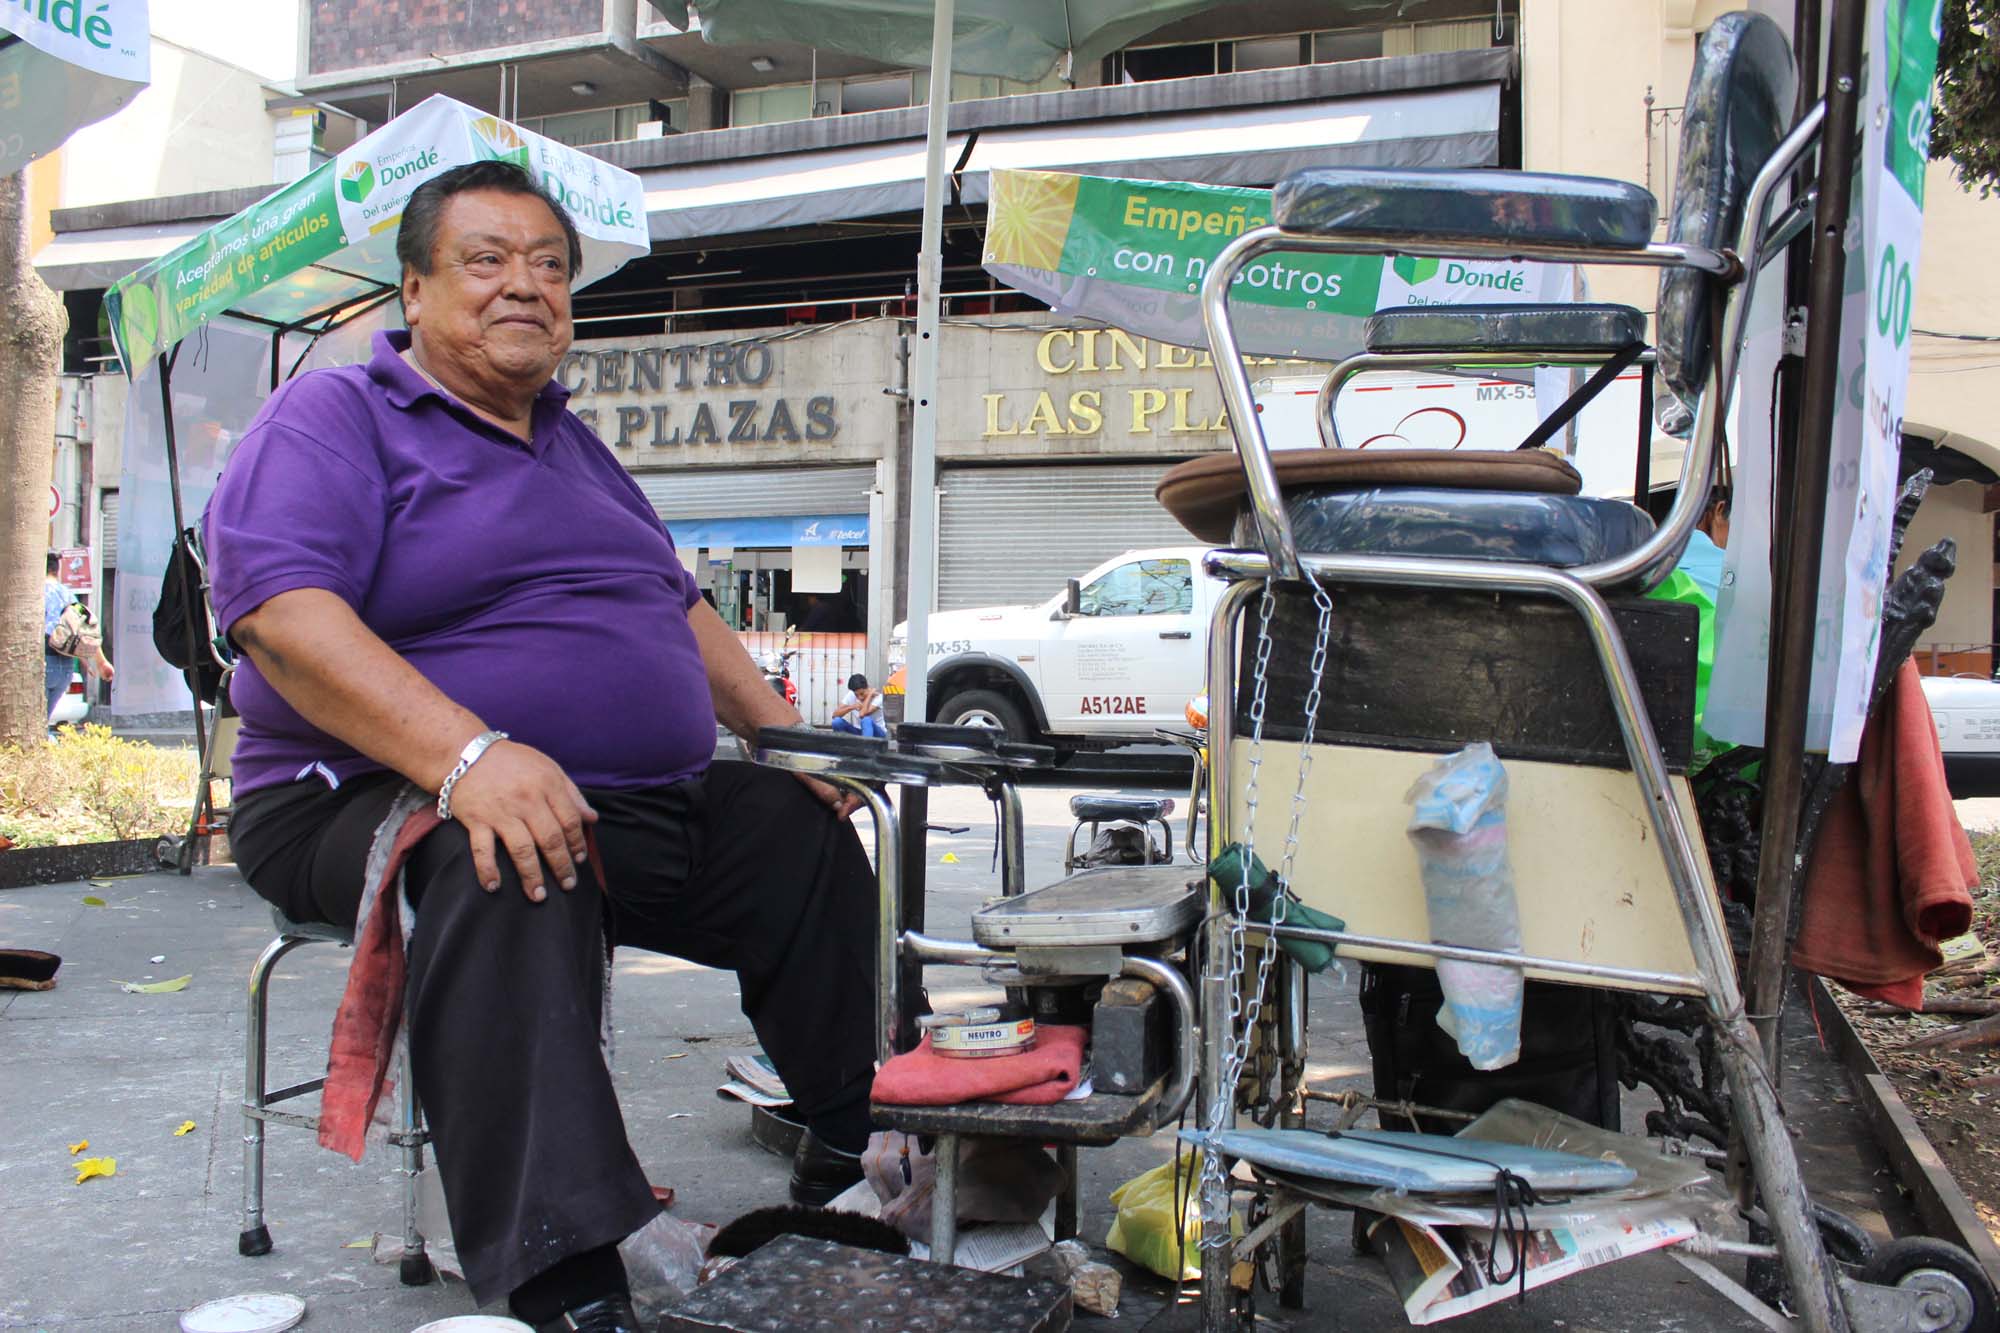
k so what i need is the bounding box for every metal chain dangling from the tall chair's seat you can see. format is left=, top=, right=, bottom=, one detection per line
left=1202, top=570, right=1334, bottom=1251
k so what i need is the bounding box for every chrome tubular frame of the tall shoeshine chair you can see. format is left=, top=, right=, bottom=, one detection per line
left=1200, top=104, right=1848, bottom=1333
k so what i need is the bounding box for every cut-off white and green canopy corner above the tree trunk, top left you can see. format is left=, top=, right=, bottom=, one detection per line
left=0, top=0, right=152, bottom=176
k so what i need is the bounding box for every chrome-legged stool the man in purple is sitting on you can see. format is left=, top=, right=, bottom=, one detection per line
left=236, top=907, right=434, bottom=1287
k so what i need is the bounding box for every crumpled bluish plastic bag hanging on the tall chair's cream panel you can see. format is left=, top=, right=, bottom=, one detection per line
left=1404, top=741, right=1522, bottom=1069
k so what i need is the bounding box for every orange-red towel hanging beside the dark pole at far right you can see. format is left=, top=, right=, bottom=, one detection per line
left=1792, top=662, right=1980, bottom=1009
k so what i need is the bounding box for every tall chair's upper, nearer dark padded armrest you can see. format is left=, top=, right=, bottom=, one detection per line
left=1272, top=166, right=1660, bottom=250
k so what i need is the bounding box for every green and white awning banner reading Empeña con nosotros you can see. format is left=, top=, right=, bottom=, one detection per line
left=986, top=170, right=1576, bottom=360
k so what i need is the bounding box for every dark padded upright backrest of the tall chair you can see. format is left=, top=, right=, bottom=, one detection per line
left=1656, top=12, right=1798, bottom=402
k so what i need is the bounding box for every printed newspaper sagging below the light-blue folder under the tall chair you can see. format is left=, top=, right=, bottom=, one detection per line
left=1372, top=1209, right=1698, bottom=1325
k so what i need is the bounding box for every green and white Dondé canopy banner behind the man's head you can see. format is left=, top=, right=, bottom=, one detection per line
left=106, top=96, right=652, bottom=374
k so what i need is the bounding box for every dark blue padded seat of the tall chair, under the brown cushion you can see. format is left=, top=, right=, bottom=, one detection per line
left=1272, top=486, right=1652, bottom=568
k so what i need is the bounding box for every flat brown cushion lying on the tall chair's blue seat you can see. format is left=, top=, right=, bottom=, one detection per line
left=1154, top=448, right=1584, bottom=546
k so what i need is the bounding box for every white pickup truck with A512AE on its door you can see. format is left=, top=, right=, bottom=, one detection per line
left=890, top=546, right=1224, bottom=741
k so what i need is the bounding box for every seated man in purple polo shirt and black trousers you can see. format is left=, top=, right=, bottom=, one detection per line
left=206, top=162, right=874, bottom=1333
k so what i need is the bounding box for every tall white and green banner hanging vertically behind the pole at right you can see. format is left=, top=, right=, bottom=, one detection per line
left=1706, top=0, right=1942, bottom=763
